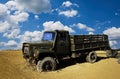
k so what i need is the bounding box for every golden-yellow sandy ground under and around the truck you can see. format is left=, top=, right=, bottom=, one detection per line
left=0, top=51, right=120, bottom=79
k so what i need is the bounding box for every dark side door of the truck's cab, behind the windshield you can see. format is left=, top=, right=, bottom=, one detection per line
left=56, top=32, right=70, bottom=56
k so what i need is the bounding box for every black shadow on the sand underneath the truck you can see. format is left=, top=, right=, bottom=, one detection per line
left=57, top=57, right=108, bottom=70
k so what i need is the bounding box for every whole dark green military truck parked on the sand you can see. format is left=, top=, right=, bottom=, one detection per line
left=22, top=30, right=115, bottom=72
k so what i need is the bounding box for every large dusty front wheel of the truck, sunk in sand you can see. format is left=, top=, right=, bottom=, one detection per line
left=37, top=57, right=56, bottom=72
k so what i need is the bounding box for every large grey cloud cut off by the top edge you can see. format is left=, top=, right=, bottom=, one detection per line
left=14, top=0, right=51, bottom=14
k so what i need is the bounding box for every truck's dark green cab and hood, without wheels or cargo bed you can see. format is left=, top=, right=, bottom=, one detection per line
left=22, top=30, right=71, bottom=65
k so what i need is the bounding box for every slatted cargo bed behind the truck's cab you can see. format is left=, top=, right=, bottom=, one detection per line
left=70, top=35, right=110, bottom=51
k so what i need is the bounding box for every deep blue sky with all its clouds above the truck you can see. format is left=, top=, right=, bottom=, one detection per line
left=0, top=0, right=120, bottom=50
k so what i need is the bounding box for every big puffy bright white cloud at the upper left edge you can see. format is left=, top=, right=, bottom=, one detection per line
left=0, top=1, right=29, bottom=38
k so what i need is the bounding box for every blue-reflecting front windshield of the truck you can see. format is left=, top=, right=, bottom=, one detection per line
left=42, top=32, right=55, bottom=41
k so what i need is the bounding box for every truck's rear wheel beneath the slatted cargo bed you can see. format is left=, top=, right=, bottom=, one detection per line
left=86, top=51, right=97, bottom=63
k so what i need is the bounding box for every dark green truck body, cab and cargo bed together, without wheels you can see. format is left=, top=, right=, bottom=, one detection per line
left=23, top=30, right=110, bottom=59
